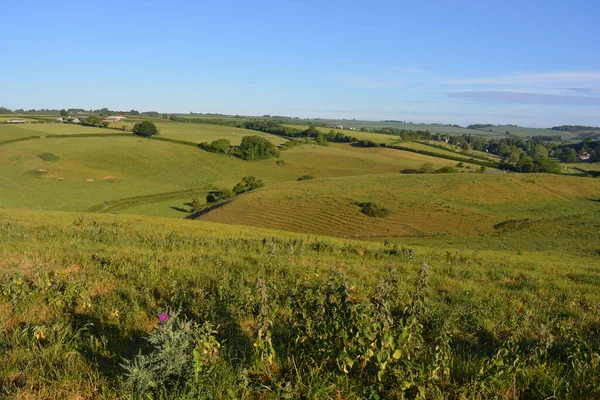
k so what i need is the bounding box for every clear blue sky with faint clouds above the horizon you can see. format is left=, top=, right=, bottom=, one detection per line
left=0, top=0, right=600, bottom=127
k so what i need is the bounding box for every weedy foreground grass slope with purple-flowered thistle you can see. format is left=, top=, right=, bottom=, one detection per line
left=0, top=209, right=600, bottom=399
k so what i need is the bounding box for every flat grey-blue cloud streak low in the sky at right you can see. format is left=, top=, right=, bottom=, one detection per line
left=447, top=90, right=600, bottom=106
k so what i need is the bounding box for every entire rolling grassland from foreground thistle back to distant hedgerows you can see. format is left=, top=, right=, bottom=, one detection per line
left=0, top=115, right=600, bottom=400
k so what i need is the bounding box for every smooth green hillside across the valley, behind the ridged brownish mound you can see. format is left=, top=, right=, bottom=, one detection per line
left=0, top=134, right=474, bottom=216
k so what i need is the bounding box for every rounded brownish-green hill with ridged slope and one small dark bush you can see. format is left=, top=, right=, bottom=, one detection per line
left=199, top=174, right=600, bottom=238
